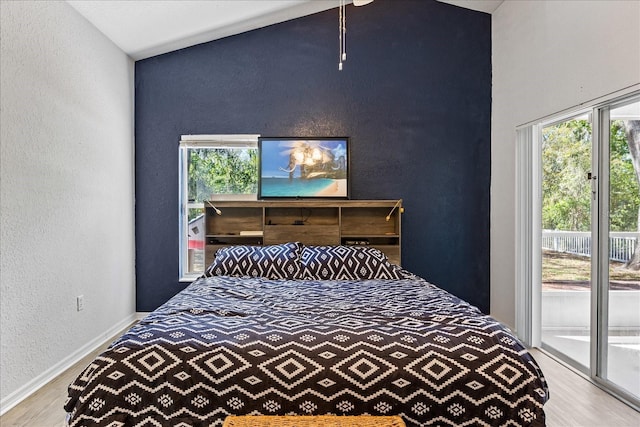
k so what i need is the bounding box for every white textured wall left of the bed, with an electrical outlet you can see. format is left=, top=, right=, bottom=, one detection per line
left=0, top=1, right=135, bottom=411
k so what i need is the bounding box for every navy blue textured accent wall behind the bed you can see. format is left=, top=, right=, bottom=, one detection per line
left=135, top=0, right=491, bottom=313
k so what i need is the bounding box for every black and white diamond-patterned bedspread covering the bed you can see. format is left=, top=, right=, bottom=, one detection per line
left=65, top=277, right=548, bottom=426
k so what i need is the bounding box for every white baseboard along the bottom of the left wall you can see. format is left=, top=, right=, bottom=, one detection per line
left=0, top=313, right=141, bottom=415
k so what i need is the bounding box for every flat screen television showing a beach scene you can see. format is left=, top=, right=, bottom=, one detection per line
left=258, top=137, right=349, bottom=199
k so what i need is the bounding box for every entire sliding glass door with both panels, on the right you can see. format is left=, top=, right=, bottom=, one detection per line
left=532, top=94, right=640, bottom=407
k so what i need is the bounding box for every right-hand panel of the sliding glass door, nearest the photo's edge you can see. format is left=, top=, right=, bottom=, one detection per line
left=596, top=99, right=640, bottom=400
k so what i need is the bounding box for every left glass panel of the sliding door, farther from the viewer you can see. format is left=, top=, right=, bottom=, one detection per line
left=540, top=114, right=592, bottom=371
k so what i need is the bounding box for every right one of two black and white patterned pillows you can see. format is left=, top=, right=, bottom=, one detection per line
left=301, top=246, right=406, bottom=280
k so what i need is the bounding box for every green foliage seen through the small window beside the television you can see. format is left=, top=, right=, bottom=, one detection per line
left=188, top=148, right=258, bottom=202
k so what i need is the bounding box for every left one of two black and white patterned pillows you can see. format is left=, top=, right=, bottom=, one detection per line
left=204, top=242, right=302, bottom=279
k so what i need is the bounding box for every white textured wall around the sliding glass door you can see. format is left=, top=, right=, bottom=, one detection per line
left=491, top=0, right=640, bottom=326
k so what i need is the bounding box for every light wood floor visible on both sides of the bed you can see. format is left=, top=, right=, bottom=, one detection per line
left=0, top=340, right=640, bottom=427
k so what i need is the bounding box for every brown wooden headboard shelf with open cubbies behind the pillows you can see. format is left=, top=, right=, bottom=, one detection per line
left=205, top=199, right=402, bottom=265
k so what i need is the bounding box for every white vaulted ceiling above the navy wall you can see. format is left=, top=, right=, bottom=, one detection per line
left=67, top=0, right=503, bottom=60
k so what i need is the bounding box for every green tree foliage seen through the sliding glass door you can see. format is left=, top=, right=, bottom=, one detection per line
left=542, top=120, right=640, bottom=231
